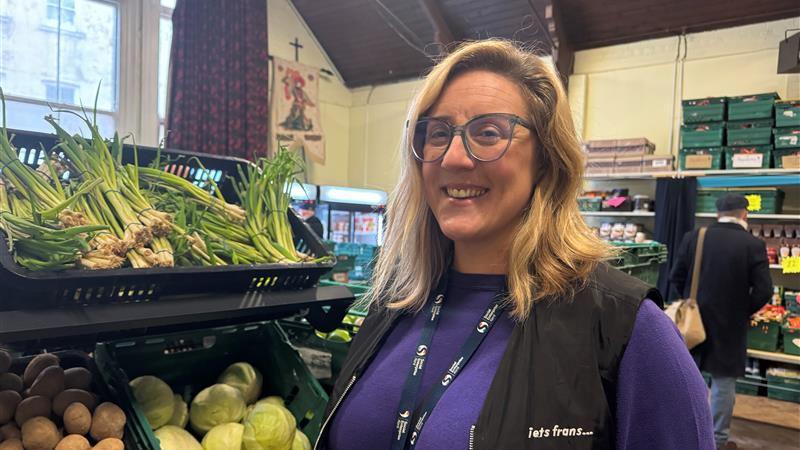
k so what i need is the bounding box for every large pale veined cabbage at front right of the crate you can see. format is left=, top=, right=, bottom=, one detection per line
left=242, top=401, right=297, bottom=450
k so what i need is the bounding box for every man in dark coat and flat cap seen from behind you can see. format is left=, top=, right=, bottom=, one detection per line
left=670, top=194, right=772, bottom=450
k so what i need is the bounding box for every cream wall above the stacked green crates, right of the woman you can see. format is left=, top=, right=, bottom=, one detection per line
left=569, top=17, right=800, bottom=154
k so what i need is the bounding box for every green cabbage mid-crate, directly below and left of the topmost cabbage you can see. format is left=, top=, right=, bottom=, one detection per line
left=189, top=384, right=246, bottom=435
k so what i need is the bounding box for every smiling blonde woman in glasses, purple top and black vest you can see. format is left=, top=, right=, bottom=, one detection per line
left=317, top=40, right=714, bottom=450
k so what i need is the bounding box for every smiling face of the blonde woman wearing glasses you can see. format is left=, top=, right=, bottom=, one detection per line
left=422, top=70, right=536, bottom=248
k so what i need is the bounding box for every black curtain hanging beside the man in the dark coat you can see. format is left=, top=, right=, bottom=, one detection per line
left=654, top=177, right=697, bottom=301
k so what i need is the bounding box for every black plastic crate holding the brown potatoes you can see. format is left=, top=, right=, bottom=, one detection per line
left=9, top=350, right=147, bottom=449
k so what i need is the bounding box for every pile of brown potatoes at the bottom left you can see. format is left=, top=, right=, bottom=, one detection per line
left=0, top=350, right=127, bottom=450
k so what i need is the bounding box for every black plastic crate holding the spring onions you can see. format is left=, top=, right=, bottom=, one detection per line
left=0, top=131, right=334, bottom=310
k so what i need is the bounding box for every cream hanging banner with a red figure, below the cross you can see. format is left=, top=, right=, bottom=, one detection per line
left=272, top=57, right=325, bottom=164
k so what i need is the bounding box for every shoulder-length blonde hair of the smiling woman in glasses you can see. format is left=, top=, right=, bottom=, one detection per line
left=367, top=39, right=609, bottom=321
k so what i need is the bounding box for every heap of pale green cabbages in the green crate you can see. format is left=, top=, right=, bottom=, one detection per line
left=130, top=362, right=311, bottom=450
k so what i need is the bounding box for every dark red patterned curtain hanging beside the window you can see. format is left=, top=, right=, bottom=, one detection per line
left=167, top=0, right=269, bottom=159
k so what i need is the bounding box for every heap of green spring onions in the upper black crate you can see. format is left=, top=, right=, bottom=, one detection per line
left=0, top=92, right=322, bottom=270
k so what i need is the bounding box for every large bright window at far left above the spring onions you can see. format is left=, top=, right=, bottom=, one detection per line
left=0, top=0, right=119, bottom=135
